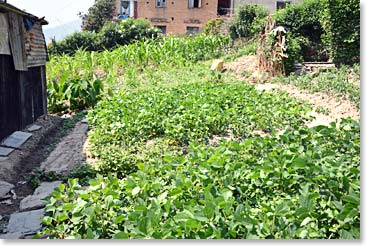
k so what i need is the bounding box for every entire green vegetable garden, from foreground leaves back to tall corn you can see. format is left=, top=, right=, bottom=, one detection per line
left=36, top=0, right=361, bottom=239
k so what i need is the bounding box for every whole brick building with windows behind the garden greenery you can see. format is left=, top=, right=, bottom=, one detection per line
left=116, top=0, right=302, bottom=34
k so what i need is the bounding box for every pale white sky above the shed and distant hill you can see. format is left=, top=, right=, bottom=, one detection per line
left=7, top=0, right=94, bottom=29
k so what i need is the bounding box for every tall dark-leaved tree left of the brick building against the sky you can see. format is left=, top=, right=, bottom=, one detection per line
left=79, top=0, right=116, bottom=32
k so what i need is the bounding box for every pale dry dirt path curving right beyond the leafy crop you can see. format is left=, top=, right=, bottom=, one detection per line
left=224, top=56, right=360, bottom=127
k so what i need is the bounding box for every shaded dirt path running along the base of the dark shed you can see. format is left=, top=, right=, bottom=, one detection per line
left=0, top=116, right=88, bottom=234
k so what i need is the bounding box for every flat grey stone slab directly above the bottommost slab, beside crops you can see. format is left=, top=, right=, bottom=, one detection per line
left=19, top=181, right=62, bottom=211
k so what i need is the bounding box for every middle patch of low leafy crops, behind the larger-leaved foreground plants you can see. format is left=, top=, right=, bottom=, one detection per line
left=88, top=81, right=309, bottom=177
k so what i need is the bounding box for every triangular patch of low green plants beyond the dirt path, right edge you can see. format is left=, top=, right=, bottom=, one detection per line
left=279, top=65, right=361, bottom=108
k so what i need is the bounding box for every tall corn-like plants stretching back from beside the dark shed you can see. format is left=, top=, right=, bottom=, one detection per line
left=47, top=34, right=229, bottom=112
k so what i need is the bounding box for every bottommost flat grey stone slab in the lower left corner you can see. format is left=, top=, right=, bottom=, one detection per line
left=7, top=209, right=44, bottom=235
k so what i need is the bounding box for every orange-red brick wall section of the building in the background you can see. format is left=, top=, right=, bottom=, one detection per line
left=138, top=0, right=218, bottom=34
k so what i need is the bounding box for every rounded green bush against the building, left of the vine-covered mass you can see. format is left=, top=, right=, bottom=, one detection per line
left=229, top=4, right=269, bottom=39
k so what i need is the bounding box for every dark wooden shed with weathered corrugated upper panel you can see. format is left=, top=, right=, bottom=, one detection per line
left=0, top=1, right=48, bottom=140
